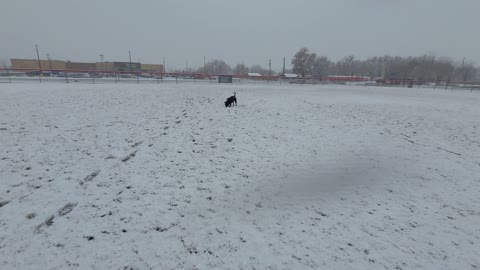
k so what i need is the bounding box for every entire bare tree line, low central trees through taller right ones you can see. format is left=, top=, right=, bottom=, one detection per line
left=172, top=48, right=480, bottom=81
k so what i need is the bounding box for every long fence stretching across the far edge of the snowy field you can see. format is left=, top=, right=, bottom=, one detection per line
left=0, top=68, right=480, bottom=91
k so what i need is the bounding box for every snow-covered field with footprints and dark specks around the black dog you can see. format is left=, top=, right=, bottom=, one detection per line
left=0, top=84, right=480, bottom=270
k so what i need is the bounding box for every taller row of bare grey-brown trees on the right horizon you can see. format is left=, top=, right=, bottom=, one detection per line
left=292, top=48, right=480, bottom=81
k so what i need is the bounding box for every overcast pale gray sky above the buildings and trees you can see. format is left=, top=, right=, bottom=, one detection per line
left=0, top=0, right=480, bottom=70
